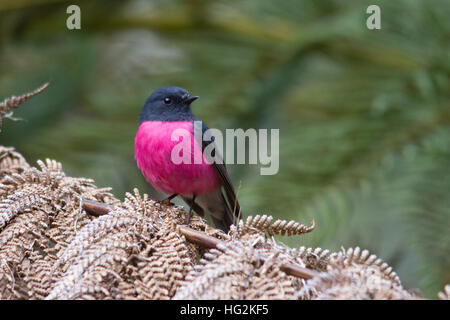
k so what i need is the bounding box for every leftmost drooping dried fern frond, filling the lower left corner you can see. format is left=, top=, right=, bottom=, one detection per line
left=0, top=151, right=118, bottom=299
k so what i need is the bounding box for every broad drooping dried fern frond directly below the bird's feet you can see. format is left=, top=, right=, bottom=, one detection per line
left=47, top=189, right=199, bottom=299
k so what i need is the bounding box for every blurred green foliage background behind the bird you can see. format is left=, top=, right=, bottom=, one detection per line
left=0, top=0, right=450, bottom=298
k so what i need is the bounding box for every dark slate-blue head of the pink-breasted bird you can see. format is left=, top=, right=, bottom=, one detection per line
left=138, top=87, right=198, bottom=125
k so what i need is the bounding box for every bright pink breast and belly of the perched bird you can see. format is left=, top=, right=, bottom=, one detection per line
left=134, top=121, right=220, bottom=195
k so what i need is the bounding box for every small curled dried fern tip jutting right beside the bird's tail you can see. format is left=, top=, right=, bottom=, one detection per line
left=238, top=215, right=314, bottom=236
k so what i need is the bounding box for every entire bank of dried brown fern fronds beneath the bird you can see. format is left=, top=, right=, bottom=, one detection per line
left=0, top=84, right=450, bottom=299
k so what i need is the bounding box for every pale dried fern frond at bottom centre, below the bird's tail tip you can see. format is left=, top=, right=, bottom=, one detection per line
left=174, top=234, right=304, bottom=299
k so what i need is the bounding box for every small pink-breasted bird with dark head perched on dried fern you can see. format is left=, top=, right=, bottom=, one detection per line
left=134, top=87, right=241, bottom=232
